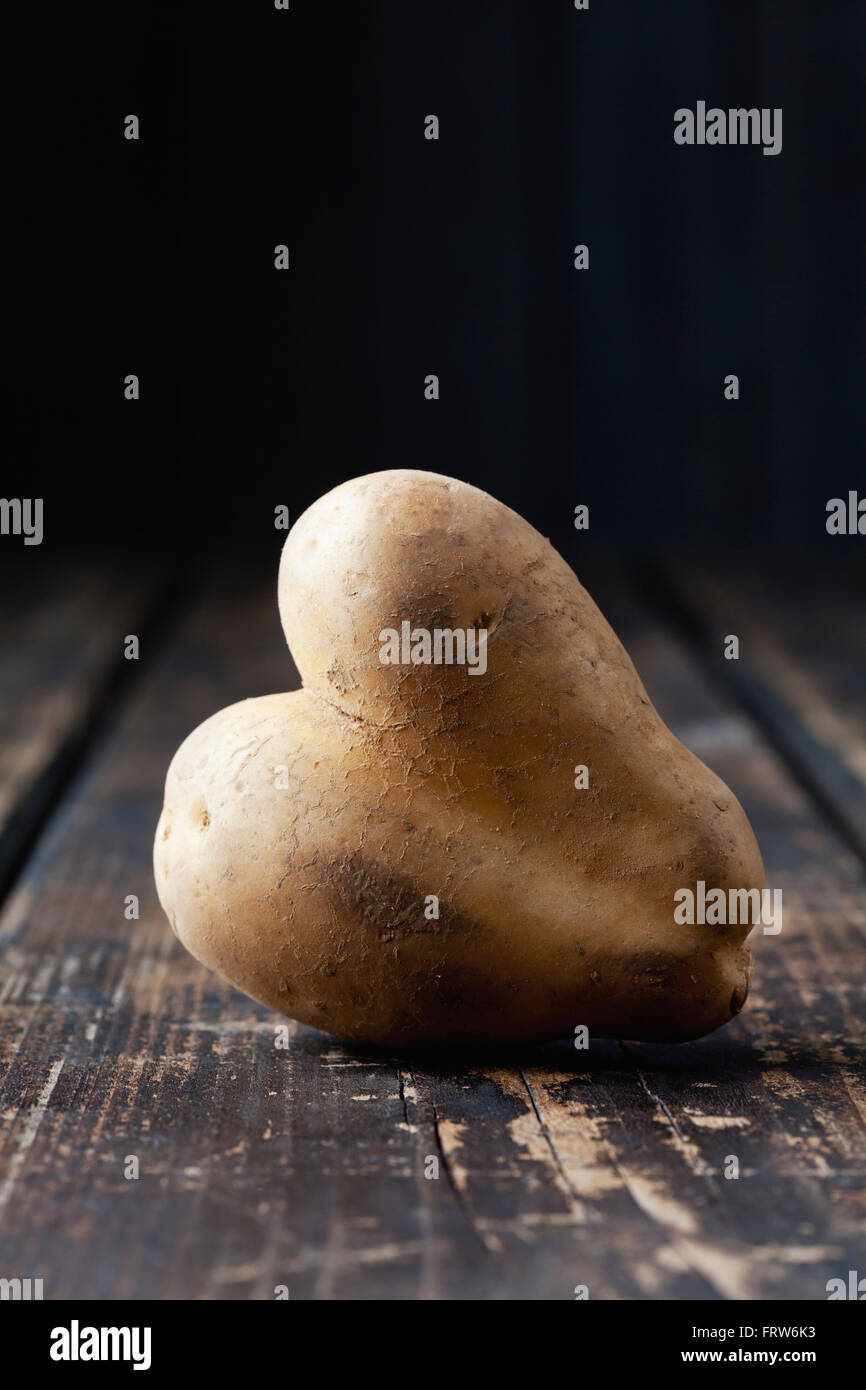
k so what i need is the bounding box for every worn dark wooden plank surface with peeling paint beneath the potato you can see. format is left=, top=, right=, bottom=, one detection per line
left=0, top=550, right=866, bottom=1300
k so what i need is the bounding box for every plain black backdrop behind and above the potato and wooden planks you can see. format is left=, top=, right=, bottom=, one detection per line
left=1, top=0, right=866, bottom=553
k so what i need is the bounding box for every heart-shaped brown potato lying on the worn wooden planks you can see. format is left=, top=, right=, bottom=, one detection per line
left=154, top=468, right=765, bottom=1045
